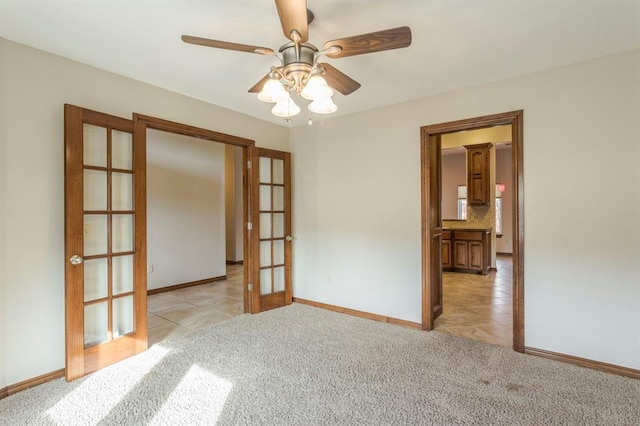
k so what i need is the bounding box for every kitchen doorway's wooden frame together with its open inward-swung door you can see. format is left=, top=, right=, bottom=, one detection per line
left=421, top=110, right=524, bottom=352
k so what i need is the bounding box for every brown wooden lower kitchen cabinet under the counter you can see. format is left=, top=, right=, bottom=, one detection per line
left=442, top=229, right=491, bottom=275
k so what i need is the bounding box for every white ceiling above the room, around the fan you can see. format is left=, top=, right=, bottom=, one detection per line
left=0, top=0, right=640, bottom=125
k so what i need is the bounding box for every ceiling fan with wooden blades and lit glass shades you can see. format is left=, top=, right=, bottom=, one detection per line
left=182, top=0, right=411, bottom=119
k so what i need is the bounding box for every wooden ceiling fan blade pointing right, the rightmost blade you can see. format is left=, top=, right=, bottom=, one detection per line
left=323, top=27, right=411, bottom=58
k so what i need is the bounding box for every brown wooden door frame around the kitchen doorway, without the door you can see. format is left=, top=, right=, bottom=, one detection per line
left=420, top=110, right=524, bottom=352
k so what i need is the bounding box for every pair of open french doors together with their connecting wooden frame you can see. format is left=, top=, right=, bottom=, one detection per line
left=65, top=105, right=292, bottom=380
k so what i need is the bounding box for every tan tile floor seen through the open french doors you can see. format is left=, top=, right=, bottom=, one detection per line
left=147, top=265, right=243, bottom=346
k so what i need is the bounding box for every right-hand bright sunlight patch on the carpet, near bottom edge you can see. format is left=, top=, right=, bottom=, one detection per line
left=149, top=365, right=233, bottom=425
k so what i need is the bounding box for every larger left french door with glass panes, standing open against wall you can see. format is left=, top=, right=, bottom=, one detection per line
left=65, top=105, right=147, bottom=380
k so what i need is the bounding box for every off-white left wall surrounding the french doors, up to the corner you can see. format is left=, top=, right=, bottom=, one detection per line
left=0, top=38, right=289, bottom=388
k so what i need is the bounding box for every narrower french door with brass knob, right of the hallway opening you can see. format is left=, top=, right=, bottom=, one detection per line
left=249, top=148, right=292, bottom=313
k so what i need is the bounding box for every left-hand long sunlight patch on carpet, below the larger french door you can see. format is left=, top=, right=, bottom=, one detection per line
left=46, top=345, right=169, bottom=425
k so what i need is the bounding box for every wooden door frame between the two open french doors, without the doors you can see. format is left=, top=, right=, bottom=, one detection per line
left=133, top=113, right=255, bottom=313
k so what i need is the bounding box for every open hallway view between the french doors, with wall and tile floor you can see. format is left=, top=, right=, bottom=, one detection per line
left=147, top=129, right=244, bottom=346
